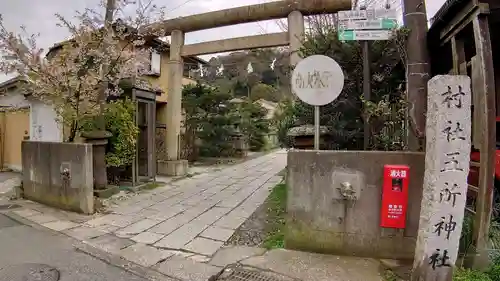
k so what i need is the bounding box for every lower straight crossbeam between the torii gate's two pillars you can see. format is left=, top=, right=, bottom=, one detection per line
left=181, top=32, right=290, bottom=57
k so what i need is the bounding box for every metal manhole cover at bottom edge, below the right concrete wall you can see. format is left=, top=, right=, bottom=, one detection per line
left=214, top=266, right=297, bottom=281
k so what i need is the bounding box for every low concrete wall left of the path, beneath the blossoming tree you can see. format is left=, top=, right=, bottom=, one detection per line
left=22, top=141, right=94, bottom=214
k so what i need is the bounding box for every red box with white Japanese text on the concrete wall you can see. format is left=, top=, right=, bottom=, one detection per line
left=380, top=165, right=410, bottom=228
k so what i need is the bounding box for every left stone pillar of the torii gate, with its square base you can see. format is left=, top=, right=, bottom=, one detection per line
left=163, top=30, right=188, bottom=176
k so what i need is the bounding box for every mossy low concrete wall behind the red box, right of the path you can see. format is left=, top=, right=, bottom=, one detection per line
left=285, top=151, right=424, bottom=259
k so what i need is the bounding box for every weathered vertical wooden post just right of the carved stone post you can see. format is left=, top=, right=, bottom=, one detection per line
left=473, top=15, right=496, bottom=268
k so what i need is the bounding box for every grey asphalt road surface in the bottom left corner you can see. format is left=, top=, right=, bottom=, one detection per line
left=0, top=213, right=150, bottom=281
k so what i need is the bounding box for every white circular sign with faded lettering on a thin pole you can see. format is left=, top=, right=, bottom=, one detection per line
left=291, top=55, right=344, bottom=106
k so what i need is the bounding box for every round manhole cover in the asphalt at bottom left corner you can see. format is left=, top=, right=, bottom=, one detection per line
left=0, top=263, right=59, bottom=281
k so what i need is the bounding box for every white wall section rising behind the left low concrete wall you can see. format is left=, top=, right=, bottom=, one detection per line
left=30, top=100, right=63, bottom=142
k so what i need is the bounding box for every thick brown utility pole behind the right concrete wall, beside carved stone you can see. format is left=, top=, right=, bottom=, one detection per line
left=403, top=0, right=430, bottom=151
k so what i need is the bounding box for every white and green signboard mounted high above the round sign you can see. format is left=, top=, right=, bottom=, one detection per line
left=337, top=9, right=397, bottom=41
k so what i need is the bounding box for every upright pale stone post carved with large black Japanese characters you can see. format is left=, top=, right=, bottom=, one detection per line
left=411, top=75, right=471, bottom=281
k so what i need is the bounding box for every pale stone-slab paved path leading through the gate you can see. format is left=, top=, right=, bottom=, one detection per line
left=7, top=151, right=286, bottom=280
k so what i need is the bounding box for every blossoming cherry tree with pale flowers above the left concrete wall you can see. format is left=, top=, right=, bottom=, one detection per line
left=0, top=0, right=165, bottom=142
